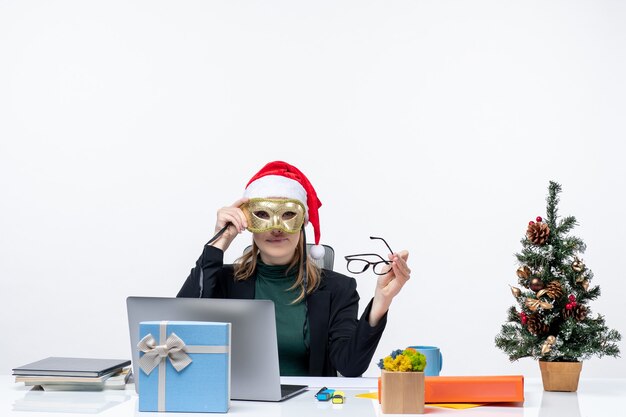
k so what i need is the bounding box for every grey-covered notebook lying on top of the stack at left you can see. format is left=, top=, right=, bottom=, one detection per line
left=13, top=356, right=130, bottom=377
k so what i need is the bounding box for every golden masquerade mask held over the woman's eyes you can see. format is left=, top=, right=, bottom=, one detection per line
left=241, top=198, right=305, bottom=233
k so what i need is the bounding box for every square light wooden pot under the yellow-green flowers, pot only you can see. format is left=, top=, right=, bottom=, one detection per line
left=380, top=370, right=424, bottom=414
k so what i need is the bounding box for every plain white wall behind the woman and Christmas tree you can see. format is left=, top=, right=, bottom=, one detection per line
left=0, top=0, right=626, bottom=377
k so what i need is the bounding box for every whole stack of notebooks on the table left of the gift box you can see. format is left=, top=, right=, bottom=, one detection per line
left=13, top=357, right=131, bottom=391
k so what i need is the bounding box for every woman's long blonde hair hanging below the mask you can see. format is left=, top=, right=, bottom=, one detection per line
left=234, top=231, right=322, bottom=304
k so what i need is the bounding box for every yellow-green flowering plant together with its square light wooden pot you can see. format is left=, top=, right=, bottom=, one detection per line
left=378, top=348, right=426, bottom=414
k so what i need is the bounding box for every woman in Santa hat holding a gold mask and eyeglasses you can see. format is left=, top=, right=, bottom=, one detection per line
left=178, top=161, right=411, bottom=376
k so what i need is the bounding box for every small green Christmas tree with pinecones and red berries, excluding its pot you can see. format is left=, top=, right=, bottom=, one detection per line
left=495, top=181, right=621, bottom=362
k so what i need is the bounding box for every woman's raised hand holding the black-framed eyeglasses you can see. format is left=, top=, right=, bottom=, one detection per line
left=369, top=250, right=411, bottom=326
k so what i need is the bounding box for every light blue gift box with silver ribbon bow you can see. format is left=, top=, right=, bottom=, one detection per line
left=137, top=321, right=230, bottom=413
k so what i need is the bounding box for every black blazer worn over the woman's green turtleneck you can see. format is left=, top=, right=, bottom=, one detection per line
left=177, top=246, right=387, bottom=377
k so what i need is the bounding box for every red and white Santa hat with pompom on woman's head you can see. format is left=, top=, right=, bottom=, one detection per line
left=243, top=161, right=324, bottom=259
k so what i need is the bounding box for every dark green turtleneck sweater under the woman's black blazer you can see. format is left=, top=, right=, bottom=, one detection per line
left=254, top=259, right=309, bottom=376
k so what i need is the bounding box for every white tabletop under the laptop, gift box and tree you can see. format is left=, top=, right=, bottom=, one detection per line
left=0, top=375, right=626, bottom=417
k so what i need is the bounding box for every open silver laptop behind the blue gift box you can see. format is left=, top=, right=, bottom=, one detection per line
left=126, top=296, right=308, bottom=401
